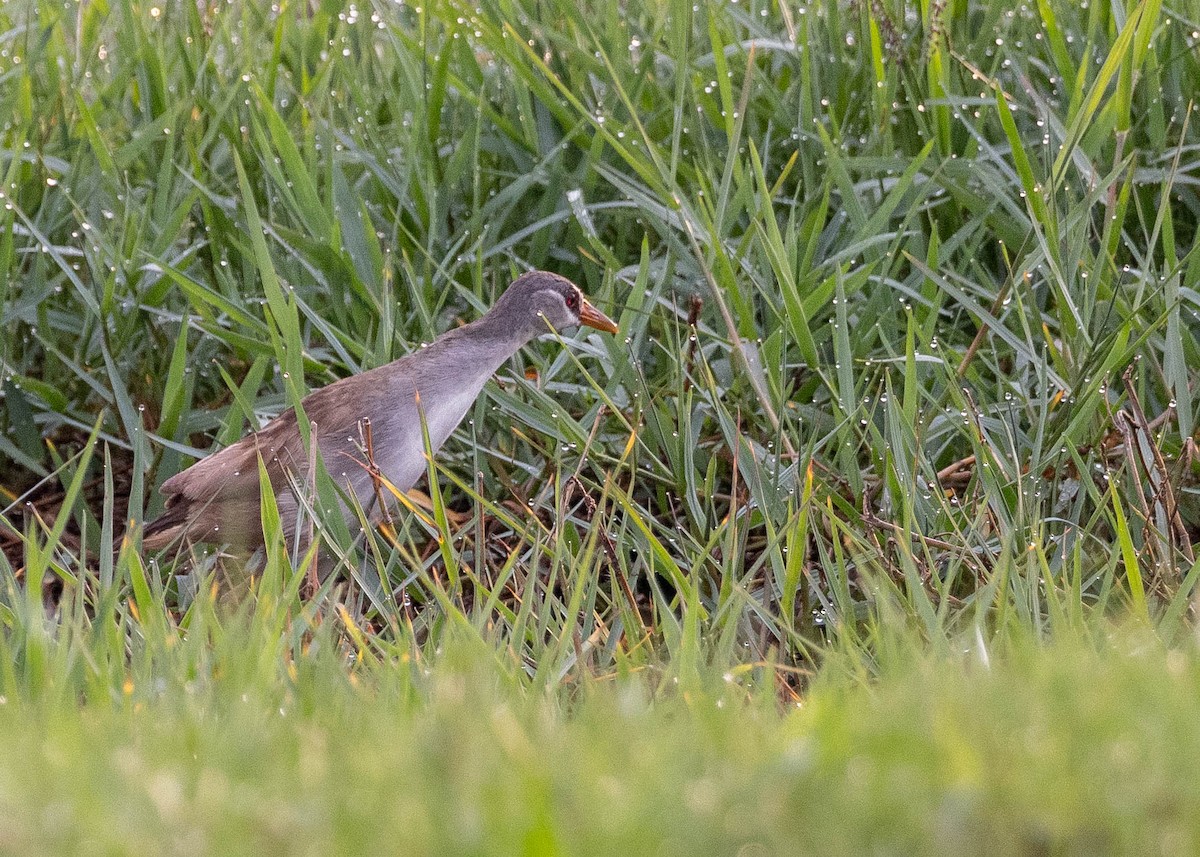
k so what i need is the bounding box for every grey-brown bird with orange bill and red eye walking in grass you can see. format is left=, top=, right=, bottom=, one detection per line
left=142, top=270, right=618, bottom=550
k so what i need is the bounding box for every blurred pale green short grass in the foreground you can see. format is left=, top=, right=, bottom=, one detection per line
left=0, top=604, right=1200, bottom=855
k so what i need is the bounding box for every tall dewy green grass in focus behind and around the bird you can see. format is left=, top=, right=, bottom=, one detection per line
left=0, top=0, right=1200, bottom=685
